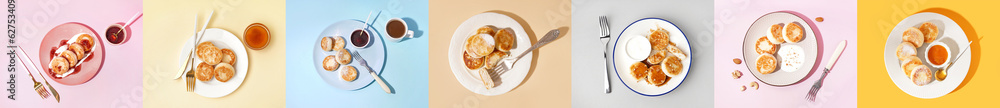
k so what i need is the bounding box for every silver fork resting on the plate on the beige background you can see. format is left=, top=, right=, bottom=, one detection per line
left=487, top=29, right=559, bottom=76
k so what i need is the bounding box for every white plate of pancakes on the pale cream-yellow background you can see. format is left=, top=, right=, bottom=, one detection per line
left=181, top=28, right=249, bottom=98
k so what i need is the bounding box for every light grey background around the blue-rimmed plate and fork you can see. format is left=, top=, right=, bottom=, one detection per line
left=572, top=0, right=714, bottom=108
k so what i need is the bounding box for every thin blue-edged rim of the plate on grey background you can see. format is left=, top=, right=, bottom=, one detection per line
left=611, top=17, right=695, bottom=97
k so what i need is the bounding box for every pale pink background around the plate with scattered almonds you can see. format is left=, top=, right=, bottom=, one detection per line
left=714, top=0, right=858, bottom=108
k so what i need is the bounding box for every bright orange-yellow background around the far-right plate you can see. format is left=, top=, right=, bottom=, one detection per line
left=858, top=0, right=1000, bottom=108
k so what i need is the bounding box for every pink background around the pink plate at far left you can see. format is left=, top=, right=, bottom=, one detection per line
left=0, top=0, right=143, bottom=108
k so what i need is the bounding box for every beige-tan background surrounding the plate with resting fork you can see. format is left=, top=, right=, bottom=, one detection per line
left=428, top=0, right=572, bottom=108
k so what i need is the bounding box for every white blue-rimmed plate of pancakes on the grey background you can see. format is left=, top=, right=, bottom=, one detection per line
left=611, top=18, right=695, bottom=96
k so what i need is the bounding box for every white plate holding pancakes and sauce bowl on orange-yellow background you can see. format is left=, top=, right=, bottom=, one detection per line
left=883, top=12, right=972, bottom=99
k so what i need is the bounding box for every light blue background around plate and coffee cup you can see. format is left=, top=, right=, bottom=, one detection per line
left=285, top=0, right=429, bottom=108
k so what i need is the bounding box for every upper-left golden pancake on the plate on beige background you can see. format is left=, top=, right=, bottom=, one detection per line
left=465, top=34, right=496, bottom=58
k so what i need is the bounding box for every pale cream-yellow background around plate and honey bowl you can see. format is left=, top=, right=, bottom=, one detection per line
left=142, top=0, right=285, bottom=108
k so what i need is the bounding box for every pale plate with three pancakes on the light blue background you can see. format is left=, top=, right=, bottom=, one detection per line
left=312, top=20, right=386, bottom=90
